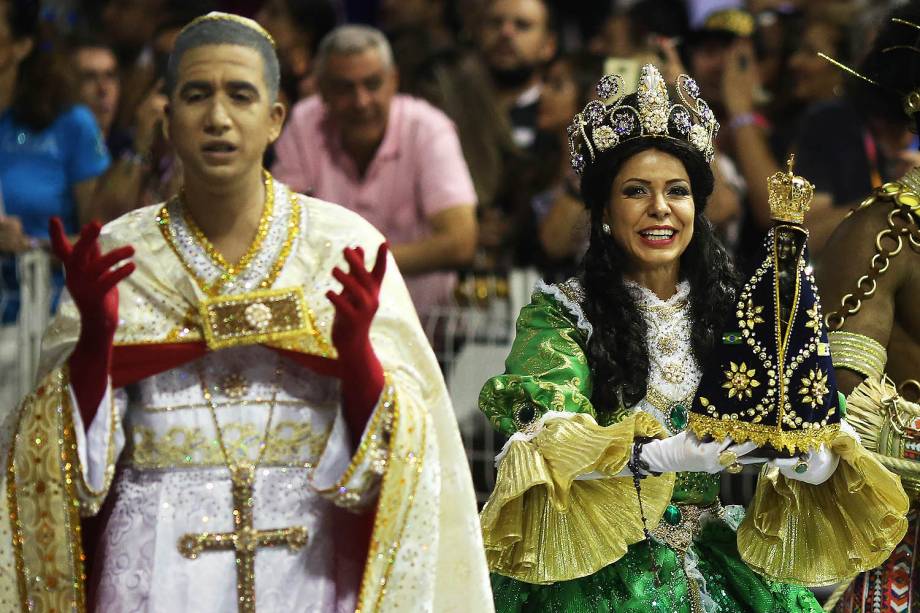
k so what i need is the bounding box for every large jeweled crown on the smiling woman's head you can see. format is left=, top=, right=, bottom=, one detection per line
left=568, top=64, right=719, bottom=174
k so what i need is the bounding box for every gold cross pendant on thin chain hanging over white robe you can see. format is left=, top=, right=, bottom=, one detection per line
left=179, top=358, right=307, bottom=613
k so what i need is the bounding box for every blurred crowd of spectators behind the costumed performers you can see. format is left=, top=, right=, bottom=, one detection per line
left=0, top=0, right=920, bottom=338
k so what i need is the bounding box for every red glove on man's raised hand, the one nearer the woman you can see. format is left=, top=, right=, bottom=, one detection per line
left=326, top=243, right=387, bottom=437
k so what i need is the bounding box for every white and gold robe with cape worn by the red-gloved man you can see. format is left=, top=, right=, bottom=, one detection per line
left=0, top=178, right=493, bottom=613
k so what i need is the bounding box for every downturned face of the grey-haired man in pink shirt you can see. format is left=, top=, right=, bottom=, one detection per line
left=319, top=49, right=398, bottom=148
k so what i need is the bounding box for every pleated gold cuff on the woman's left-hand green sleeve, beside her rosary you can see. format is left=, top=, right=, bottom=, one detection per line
left=480, top=413, right=674, bottom=584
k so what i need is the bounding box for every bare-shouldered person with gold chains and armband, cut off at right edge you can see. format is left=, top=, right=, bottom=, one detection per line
left=817, top=0, right=920, bottom=613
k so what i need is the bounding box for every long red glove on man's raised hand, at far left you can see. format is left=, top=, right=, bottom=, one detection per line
left=49, top=217, right=134, bottom=429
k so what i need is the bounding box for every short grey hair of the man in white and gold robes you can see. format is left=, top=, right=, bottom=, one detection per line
left=166, top=19, right=281, bottom=102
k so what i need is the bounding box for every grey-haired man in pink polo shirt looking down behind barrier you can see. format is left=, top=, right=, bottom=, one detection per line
left=272, top=25, right=476, bottom=317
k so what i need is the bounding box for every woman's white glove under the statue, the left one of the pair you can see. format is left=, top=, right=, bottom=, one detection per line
left=642, top=430, right=762, bottom=473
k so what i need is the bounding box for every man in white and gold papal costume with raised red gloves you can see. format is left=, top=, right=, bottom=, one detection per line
left=0, top=13, right=492, bottom=613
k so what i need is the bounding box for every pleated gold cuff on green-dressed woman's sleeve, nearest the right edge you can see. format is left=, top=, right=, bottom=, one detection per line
left=738, top=434, right=908, bottom=587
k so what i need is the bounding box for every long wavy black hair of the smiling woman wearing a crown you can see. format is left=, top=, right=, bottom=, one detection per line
left=581, top=137, right=740, bottom=414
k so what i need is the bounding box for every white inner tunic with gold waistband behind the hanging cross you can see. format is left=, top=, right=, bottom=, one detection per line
left=74, top=346, right=374, bottom=613
